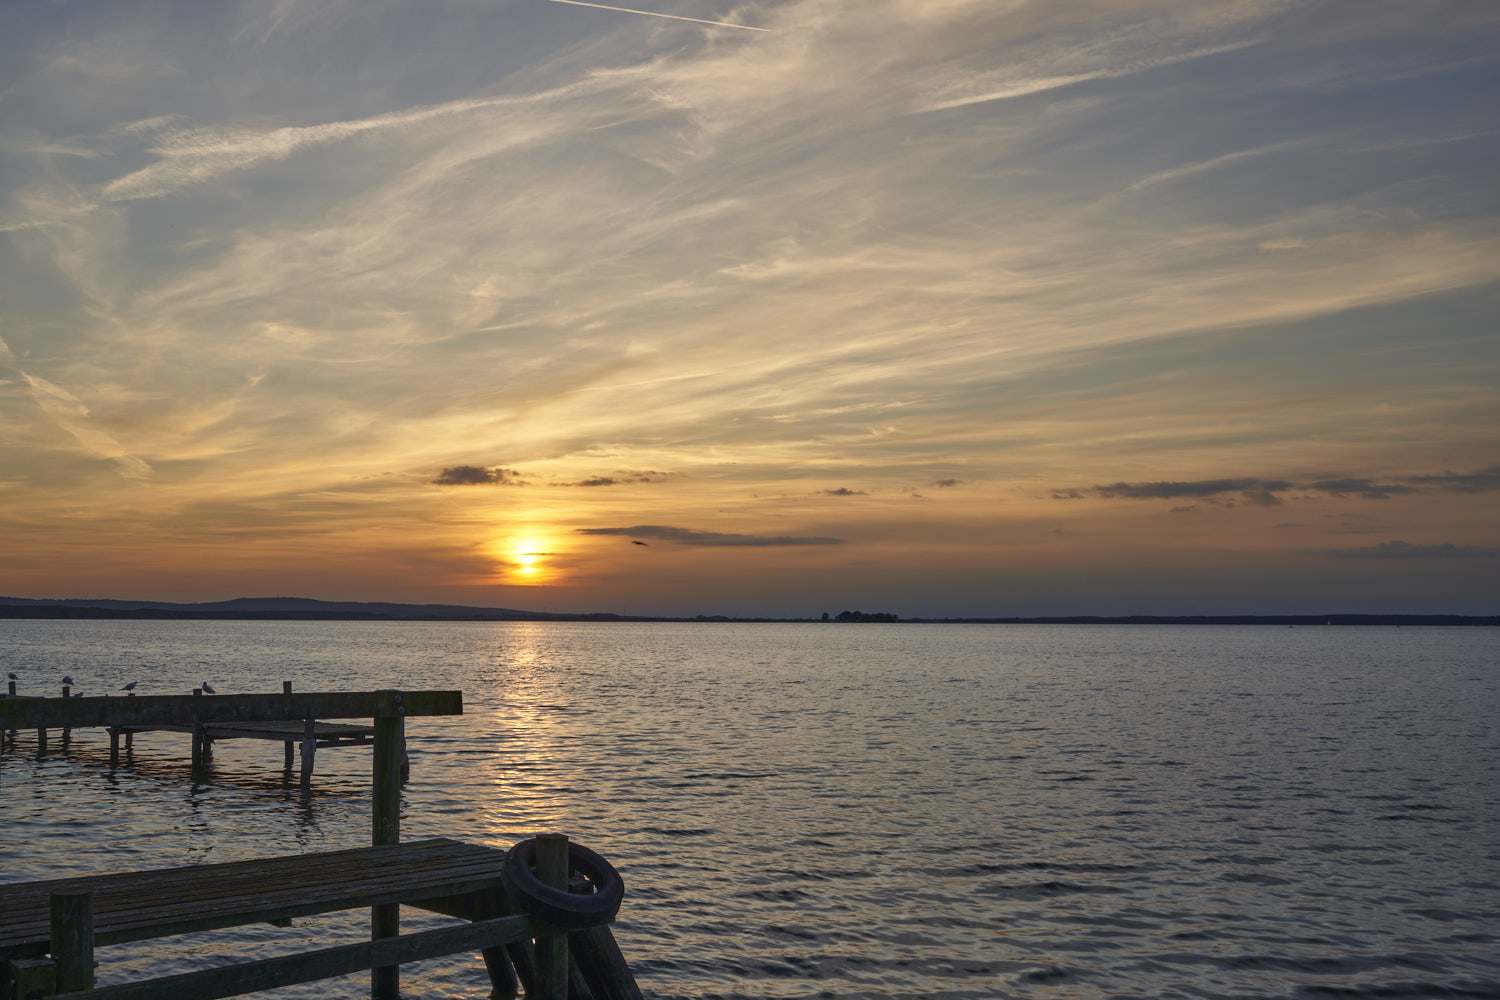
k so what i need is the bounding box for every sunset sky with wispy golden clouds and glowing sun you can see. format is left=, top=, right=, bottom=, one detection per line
left=0, top=0, right=1500, bottom=616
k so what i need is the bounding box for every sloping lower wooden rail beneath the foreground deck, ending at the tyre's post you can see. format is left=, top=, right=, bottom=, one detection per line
left=56, top=916, right=548, bottom=1000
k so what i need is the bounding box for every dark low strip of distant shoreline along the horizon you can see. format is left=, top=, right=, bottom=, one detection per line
left=0, top=597, right=1500, bottom=627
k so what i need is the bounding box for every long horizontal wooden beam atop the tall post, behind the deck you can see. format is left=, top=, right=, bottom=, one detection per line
left=0, top=691, right=464, bottom=729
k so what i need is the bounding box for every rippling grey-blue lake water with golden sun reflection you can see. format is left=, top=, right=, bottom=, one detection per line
left=0, top=621, right=1500, bottom=1000
